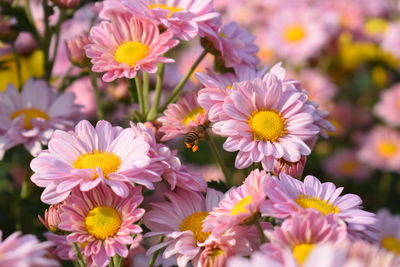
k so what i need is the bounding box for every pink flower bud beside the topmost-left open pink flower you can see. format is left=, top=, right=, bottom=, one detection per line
left=65, top=33, right=90, bottom=67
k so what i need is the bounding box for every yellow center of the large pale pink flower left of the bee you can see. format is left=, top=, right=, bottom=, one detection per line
left=72, top=150, right=121, bottom=179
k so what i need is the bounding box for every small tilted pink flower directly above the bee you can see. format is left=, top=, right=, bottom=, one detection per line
left=158, top=91, right=208, bottom=141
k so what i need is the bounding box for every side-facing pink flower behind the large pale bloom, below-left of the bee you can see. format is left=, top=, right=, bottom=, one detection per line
left=131, top=123, right=207, bottom=191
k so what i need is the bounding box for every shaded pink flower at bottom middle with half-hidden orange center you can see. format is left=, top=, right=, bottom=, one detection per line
left=144, top=189, right=223, bottom=267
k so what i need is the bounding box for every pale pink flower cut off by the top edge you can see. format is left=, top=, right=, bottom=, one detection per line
left=122, top=0, right=220, bottom=41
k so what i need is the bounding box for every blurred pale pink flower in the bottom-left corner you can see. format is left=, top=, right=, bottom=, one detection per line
left=0, top=231, right=60, bottom=267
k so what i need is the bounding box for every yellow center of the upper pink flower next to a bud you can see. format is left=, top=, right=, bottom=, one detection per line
left=114, top=42, right=150, bottom=67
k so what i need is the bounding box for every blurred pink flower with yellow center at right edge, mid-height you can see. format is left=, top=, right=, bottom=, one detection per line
left=358, top=126, right=400, bottom=171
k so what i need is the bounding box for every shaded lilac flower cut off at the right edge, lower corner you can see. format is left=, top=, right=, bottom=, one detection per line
left=376, top=209, right=400, bottom=256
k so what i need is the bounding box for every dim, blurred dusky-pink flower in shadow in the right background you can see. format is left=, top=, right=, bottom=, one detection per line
left=323, top=149, right=370, bottom=181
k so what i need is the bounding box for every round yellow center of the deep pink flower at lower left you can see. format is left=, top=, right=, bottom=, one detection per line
left=85, top=206, right=121, bottom=240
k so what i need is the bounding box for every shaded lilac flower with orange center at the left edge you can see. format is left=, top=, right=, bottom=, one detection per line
left=0, top=79, right=81, bottom=159
